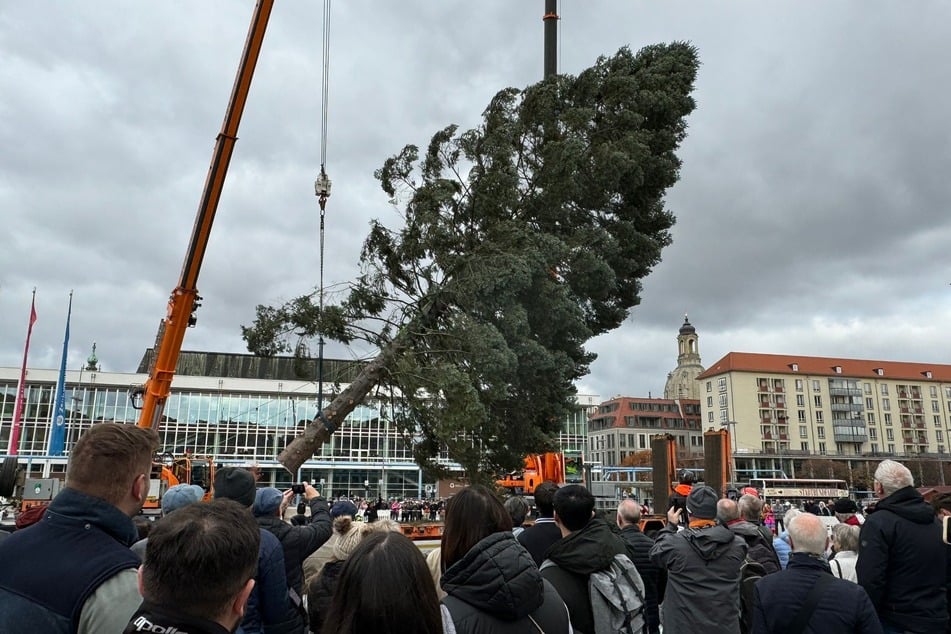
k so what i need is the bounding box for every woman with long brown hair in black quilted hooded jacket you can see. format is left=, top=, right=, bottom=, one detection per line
left=440, top=485, right=571, bottom=634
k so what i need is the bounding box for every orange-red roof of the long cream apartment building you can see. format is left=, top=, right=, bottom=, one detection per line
left=697, top=352, right=951, bottom=382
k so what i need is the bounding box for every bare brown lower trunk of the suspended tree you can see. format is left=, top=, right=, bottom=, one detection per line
left=277, top=342, right=403, bottom=477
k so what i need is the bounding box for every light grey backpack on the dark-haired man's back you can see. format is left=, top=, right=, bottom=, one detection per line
left=540, top=554, right=647, bottom=634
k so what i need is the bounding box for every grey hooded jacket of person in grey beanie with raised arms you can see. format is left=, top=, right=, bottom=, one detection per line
left=651, top=524, right=747, bottom=634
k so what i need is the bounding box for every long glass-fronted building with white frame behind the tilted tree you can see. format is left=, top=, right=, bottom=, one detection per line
left=0, top=351, right=598, bottom=498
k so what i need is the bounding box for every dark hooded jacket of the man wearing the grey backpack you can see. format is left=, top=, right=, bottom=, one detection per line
left=542, top=518, right=627, bottom=634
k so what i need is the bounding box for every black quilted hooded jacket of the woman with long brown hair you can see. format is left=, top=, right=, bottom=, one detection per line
left=440, top=531, right=568, bottom=634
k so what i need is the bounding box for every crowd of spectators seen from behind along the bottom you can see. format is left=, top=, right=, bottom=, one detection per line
left=0, top=423, right=951, bottom=634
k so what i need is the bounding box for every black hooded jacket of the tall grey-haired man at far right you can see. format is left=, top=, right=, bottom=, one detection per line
left=855, top=486, right=948, bottom=632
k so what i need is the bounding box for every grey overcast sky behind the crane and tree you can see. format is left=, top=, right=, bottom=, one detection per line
left=0, top=0, right=951, bottom=399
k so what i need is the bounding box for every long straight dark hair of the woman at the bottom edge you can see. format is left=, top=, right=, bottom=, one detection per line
left=322, top=531, right=453, bottom=634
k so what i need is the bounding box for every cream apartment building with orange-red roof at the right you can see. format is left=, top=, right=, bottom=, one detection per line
left=697, top=352, right=951, bottom=472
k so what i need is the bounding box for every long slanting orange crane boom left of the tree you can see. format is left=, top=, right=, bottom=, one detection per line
left=132, top=0, right=274, bottom=431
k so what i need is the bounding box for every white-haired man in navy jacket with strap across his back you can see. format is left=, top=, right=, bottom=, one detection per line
left=753, top=513, right=882, bottom=634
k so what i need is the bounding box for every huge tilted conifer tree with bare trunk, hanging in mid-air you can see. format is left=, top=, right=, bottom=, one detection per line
left=242, top=43, right=699, bottom=479
